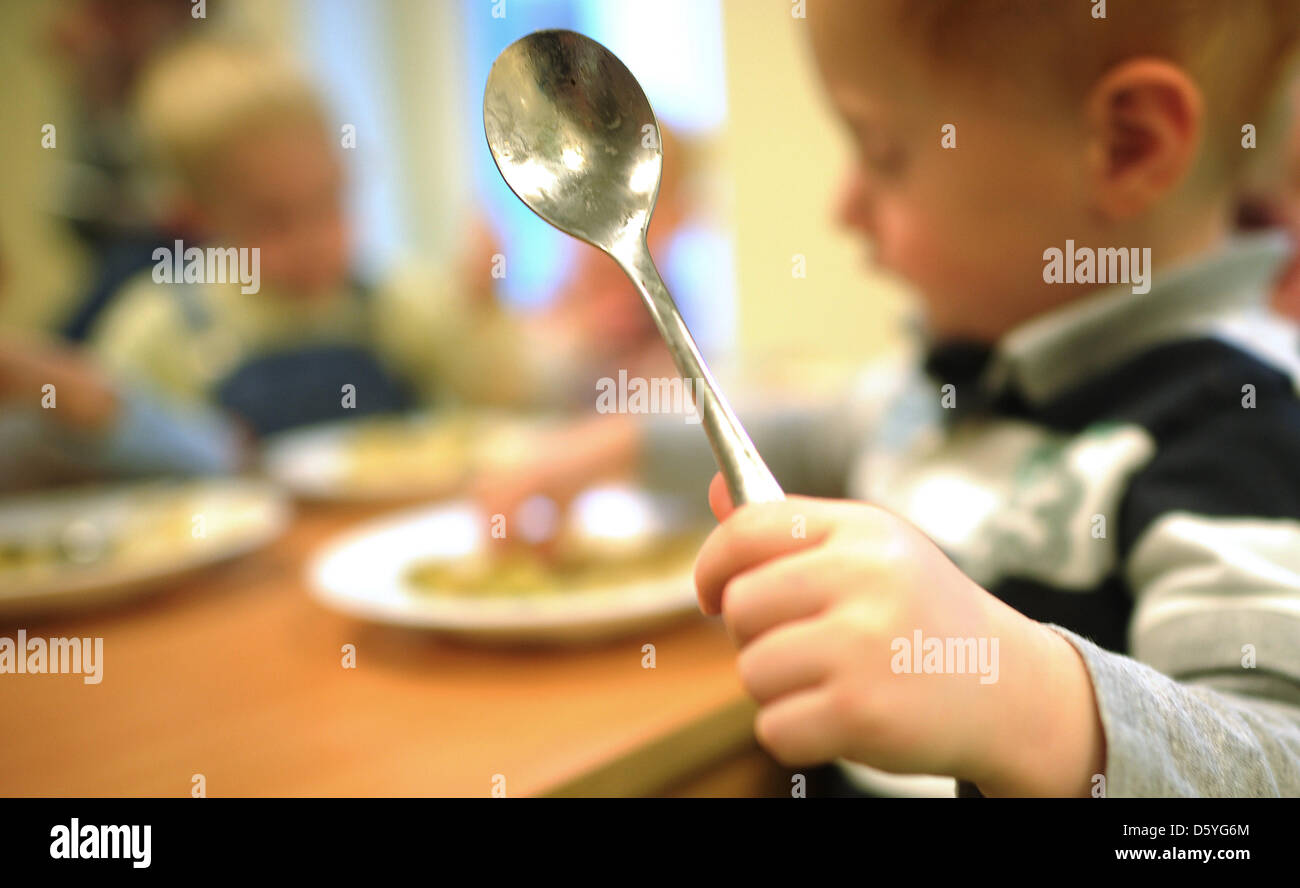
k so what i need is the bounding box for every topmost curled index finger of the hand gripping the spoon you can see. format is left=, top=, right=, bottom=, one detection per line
left=696, top=497, right=833, bottom=614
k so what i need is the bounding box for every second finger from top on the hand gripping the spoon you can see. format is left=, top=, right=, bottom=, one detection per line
left=720, top=547, right=842, bottom=647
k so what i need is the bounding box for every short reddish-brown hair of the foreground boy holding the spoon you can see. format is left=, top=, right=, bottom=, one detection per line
left=893, top=0, right=1300, bottom=179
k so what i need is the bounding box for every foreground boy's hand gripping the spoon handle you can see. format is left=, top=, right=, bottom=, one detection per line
left=696, top=476, right=1101, bottom=794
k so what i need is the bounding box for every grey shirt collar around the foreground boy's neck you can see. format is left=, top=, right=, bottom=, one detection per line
left=926, top=231, right=1291, bottom=403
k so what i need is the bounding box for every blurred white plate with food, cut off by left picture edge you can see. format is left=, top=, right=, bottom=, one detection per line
left=0, top=478, right=290, bottom=618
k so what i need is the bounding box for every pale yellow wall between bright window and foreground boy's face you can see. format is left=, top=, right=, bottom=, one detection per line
left=722, top=0, right=902, bottom=361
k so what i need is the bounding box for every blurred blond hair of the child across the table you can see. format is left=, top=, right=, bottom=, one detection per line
left=135, top=42, right=328, bottom=194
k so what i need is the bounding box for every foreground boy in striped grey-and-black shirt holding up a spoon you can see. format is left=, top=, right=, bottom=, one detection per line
left=483, top=0, right=1300, bottom=796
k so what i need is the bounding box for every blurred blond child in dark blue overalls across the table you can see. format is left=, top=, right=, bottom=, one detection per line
left=94, top=44, right=536, bottom=436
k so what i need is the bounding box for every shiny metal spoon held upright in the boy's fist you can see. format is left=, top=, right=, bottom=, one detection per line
left=484, top=30, right=785, bottom=506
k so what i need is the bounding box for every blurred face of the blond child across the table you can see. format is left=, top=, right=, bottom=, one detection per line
left=204, top=118, right=351, bottom=300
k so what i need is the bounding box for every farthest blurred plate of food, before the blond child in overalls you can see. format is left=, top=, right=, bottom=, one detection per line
left=261, top=410, right=550, bottom=503
